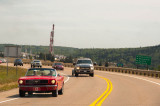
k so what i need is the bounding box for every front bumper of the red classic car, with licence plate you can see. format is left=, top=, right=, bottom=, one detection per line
left=19, top=85, right=57, bottom=92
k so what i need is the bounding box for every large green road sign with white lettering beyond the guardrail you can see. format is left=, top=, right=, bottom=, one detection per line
left=136, top=55, right=151, bottom=65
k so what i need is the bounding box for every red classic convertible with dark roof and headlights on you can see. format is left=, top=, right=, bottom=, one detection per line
left=18, top=68, right=64, bottom=97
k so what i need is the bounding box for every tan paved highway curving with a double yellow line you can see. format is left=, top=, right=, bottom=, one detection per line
left=0, top=64, right=160, bottom=106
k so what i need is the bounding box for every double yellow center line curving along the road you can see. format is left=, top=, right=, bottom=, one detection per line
left=90, top=75, right=113, bottom=106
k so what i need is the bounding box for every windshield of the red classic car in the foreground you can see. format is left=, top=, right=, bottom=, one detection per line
left=26, top=69, right=56, bottom=76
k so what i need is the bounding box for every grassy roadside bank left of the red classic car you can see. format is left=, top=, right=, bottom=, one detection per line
left=0, top=66, right=27, bottom=92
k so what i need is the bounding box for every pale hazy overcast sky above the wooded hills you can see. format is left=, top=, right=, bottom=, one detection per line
left=0, top=0, right=160, bottom=48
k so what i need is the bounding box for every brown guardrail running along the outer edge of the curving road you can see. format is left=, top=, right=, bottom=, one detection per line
left=21, top=62, right=160, bottom=78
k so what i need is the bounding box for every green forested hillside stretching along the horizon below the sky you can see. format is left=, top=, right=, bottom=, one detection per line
left=0, top=44, right=160, bottom=69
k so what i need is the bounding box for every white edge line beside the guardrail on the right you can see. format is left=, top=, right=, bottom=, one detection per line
left=99, top=71, right=160, bottom=85
